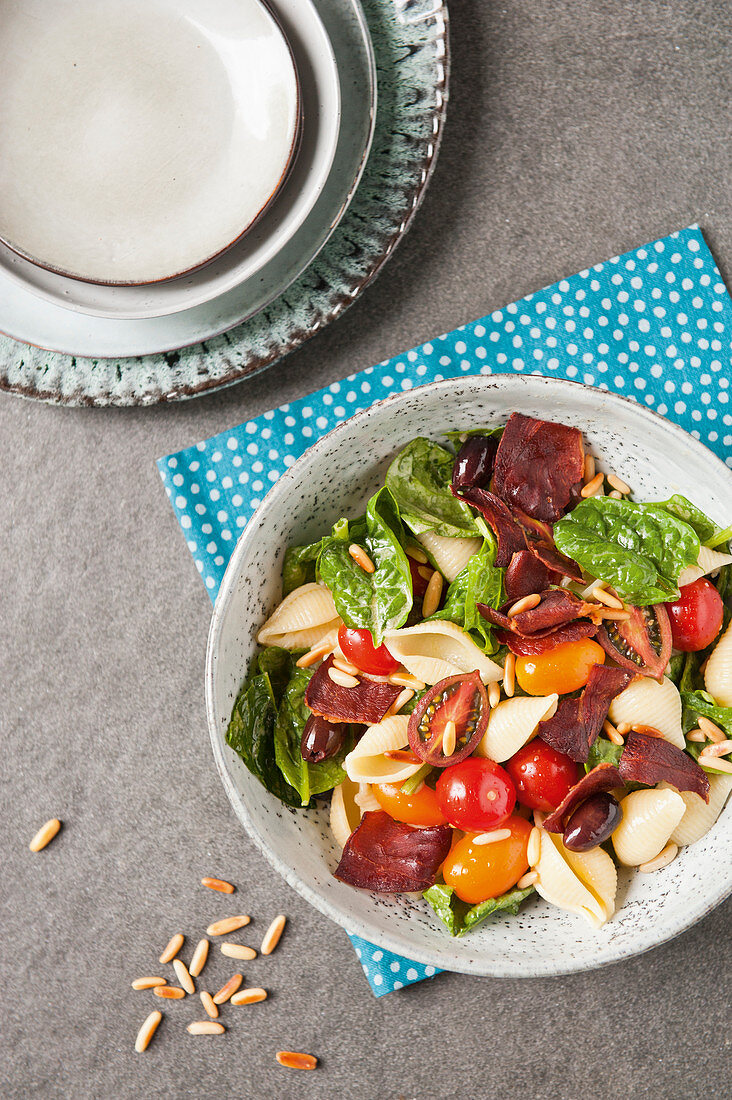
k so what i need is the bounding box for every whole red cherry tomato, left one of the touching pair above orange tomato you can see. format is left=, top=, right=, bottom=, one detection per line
left=435, top=757, right=516, bottom=833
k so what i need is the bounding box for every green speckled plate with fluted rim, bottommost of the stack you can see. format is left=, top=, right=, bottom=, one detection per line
left=0, top=0, right=448, bottom=405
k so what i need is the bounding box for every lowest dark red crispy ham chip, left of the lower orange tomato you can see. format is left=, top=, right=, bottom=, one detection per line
left=335, top=810, right=452, bottom=893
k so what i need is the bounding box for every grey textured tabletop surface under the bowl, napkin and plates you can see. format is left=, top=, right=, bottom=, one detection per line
left=0, top=0, right=732, bottom=1100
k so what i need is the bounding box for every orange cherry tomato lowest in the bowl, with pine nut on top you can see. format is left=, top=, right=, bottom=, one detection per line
left=443, top=814, right=532, bottom=905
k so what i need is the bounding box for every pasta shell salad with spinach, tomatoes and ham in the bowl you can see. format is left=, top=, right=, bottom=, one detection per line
left=227, top=413, right=732, bottom=935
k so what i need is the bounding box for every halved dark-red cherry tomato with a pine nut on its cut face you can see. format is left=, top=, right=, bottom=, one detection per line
left=407, top=672, right=489, bottom=768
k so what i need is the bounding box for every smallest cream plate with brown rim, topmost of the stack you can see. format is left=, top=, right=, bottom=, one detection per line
left=0, top=0, right=301, bottom=284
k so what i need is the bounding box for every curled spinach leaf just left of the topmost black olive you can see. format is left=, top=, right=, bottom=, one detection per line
left=386, top=437, right=478, bottom=538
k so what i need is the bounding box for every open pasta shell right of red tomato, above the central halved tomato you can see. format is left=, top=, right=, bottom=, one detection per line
left=384, top=622, right=503, bottom=684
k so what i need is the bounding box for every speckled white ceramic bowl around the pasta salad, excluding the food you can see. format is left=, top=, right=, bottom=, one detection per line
left=206, top=375, right=732, bottom=977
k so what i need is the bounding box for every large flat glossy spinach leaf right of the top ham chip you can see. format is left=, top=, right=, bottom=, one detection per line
left=554, top=496, right=700, bottom=606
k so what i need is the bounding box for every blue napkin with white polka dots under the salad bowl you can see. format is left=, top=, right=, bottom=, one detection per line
left=157, top=226, right=732, bottom=997
